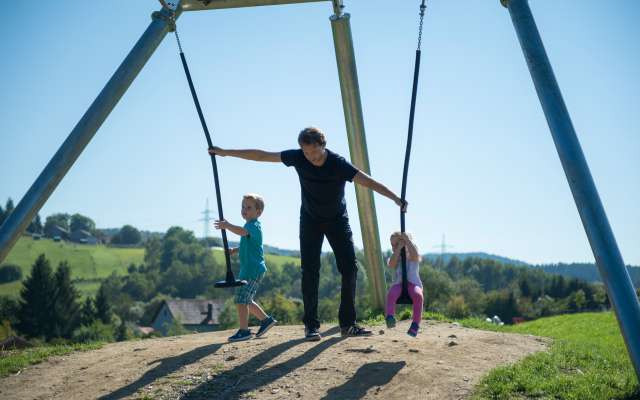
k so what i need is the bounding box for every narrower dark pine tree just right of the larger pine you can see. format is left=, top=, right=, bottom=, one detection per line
left=52, top=261, right=80, bottom=339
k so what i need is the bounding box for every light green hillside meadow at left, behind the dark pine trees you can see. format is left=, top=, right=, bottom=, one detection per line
left=0, top=236, right=144, bottom=297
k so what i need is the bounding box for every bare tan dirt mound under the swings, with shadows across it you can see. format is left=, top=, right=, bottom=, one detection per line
left=0, top=321, right=548, bottom=400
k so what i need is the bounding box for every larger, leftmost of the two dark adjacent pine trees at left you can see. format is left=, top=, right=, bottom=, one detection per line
left=16, top=254, right=55, bottom=339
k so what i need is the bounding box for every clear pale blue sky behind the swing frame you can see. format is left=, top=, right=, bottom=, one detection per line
left=0, top=0, right=640, bottom=265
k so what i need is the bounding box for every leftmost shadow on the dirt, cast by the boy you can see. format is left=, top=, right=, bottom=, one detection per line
left=99, top=343, right=225, bottom=400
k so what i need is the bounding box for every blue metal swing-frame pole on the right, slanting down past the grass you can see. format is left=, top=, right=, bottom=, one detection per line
left=501, top=0, right=640, bottom=381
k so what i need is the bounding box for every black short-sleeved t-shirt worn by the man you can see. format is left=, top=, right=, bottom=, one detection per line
left=280, top=149, right=358, bottom=222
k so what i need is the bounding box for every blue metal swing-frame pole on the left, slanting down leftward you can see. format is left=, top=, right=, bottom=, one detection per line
left=0, top=8, right=179, bottom=262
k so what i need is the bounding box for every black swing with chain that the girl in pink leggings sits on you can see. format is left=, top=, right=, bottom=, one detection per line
left=397, top=0, right=427, bottom=304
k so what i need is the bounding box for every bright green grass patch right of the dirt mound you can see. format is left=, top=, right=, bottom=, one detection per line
left=459, top=312, right=640, bottom=400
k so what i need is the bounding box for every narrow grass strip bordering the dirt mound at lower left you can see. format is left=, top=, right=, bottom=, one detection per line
left=0, top=343, right=103, bottom=377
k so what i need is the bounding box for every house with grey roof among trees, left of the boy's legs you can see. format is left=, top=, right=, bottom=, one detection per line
left=151, top=299, right=224, bottom=335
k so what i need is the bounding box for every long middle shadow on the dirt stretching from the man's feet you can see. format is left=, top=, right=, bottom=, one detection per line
left=182, top=327, right=344, bottom=400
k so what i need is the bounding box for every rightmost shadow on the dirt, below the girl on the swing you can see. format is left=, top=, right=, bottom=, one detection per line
left=322, top=361, right=406, bottom=400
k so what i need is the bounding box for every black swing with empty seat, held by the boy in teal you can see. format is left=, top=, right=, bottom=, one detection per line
left=174, top=26, right=247, bottom=287
